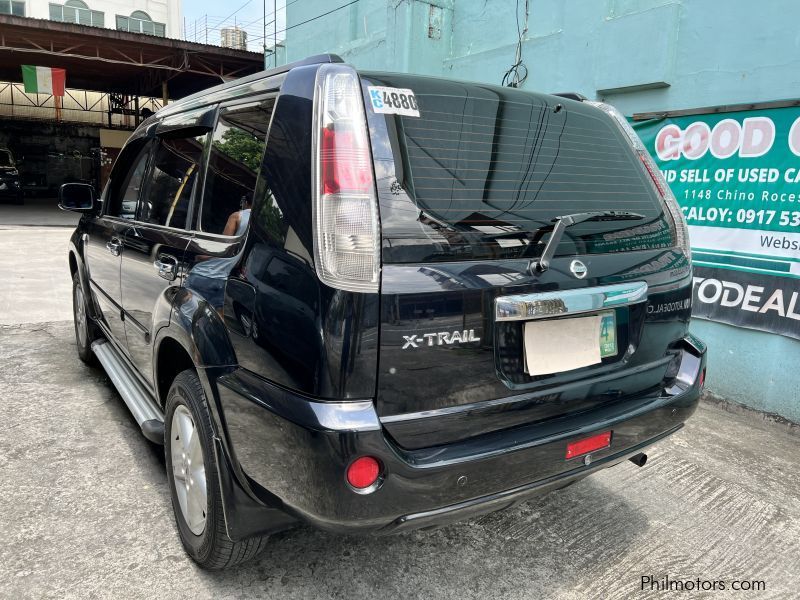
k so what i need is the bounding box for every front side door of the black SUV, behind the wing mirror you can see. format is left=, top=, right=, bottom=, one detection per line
left=87, top=138, right=151, bottom=351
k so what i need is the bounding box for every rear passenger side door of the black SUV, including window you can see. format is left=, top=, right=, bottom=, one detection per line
left=121, top=111, right=213, bottom=379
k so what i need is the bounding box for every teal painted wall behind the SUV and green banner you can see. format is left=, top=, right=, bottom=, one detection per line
left=285, top=0, right=800, bottom=422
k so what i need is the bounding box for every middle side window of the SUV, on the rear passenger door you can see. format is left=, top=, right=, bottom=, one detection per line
left=137, top=134, right=208, bottom=228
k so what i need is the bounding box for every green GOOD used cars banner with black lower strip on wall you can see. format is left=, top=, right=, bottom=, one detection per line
left=632, top=107, right=800, bottom=339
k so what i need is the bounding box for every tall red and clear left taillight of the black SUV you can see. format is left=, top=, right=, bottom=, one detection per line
left=314, top=65, right=380, bottom=292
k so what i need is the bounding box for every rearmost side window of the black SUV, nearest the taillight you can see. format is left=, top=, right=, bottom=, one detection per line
left=200, top=98, right=275, bottom=235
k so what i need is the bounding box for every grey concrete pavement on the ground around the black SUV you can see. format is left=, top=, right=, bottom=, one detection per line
left=0, top=223, right=800, bottom=600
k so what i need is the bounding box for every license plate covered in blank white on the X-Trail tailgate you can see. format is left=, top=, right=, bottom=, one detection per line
left=525, top=311, right=617, bottom=376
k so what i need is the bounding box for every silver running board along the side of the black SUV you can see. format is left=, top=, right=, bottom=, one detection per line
left=92, top=340, right=164, bottom=444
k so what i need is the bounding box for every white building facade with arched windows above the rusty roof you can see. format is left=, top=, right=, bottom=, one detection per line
left=0, top=0, right=182, bottom=39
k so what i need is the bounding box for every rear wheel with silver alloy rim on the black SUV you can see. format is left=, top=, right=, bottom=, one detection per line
left=164, top=369, right=267, bottom=570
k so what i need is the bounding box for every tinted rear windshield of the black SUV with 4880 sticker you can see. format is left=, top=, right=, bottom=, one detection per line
left=361, top=73, right=672, bottom=262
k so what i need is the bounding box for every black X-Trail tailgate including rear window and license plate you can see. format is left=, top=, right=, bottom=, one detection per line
left=362, top=74, right=690, bottom=447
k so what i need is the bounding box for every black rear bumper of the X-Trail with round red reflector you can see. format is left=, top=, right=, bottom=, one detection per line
left=215, top=339, right=705, bottom=537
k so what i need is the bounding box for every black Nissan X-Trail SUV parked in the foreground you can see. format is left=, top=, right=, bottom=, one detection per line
left=61, top=55, right=705, bottom=568
